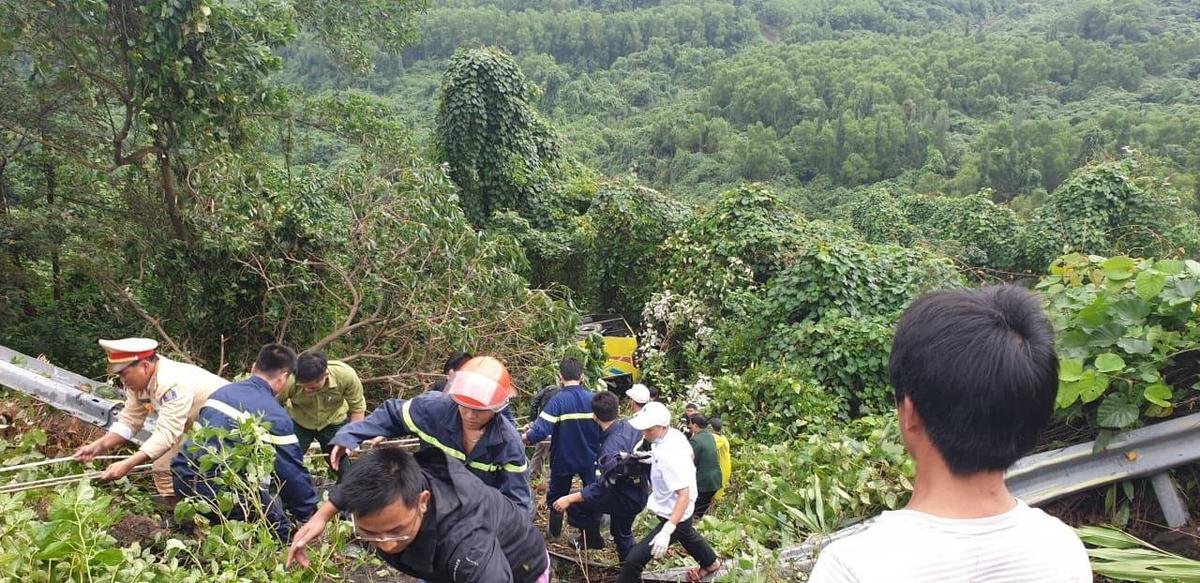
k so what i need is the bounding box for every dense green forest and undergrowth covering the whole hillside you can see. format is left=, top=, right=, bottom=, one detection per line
left=0, top=0, right=1200, bottom=581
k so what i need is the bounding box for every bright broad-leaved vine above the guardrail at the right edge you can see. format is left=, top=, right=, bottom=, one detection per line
left=1037, top=253, right=1200, bottom=429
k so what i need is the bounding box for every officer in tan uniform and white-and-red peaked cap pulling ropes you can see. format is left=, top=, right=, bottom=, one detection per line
left=74, top=338, right=229, bottom=503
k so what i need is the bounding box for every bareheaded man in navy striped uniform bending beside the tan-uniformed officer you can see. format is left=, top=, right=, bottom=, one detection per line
left=170, top=344, right=317, bottom=541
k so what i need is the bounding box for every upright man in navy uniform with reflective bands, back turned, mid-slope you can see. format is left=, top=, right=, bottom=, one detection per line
left=524, top=357, right=600, bottom=539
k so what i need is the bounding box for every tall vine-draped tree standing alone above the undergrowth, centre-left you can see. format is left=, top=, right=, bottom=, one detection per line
left=437, top=48, right=558, bottom=227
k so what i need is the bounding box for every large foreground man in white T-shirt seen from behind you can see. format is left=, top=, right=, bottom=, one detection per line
left=809, top=286, right=1092, bottom=583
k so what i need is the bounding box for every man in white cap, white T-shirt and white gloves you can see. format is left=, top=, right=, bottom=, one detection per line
left=617, top=401, right=721, bottom=583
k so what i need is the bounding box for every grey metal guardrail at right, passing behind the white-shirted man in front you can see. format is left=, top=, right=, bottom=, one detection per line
left=758, top=413, right=1200, bottom=581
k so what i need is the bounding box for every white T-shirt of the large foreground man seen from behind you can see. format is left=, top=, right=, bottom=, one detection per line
left=809, top=500, right=1092, bottom=583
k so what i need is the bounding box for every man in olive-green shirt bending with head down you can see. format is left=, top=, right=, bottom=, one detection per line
left=277, top=351, right=367, bottom=470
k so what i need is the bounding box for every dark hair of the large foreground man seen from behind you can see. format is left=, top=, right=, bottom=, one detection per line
left=890, top=286, right=1058, bottom=476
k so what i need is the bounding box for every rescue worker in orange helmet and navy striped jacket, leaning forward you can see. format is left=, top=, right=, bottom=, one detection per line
left=330, top=356, right=533, bottom=513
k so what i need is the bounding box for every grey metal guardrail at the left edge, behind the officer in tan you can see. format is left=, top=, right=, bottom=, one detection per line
left=0, top=347, right=156, bottom=444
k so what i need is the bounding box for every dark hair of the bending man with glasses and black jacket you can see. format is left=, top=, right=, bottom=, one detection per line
left=337, top=447, right=425, bottom=516
